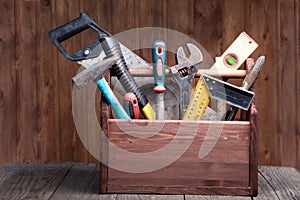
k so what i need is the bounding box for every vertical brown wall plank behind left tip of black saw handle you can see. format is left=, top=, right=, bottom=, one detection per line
left=37, top=0, right=60, bottom=162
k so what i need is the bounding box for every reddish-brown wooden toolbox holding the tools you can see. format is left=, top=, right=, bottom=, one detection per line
left=100, top=71, right=258, bottom=196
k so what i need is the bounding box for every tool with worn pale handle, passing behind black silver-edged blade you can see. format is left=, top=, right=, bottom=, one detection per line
left=222, top=56, right=265, bottom=121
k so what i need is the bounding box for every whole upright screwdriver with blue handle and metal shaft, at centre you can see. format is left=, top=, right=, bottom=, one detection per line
left=152, top=40, right=166, bottom=120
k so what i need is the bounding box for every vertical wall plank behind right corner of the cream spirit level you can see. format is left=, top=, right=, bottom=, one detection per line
left=245, top=0, right=280, bottom=165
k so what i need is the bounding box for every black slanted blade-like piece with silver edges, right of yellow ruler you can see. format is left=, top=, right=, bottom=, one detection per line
left=202, top=74, right=255, bottom=110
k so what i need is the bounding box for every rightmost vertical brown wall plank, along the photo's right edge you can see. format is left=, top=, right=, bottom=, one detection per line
left=277, top=0, right=297, bottom=166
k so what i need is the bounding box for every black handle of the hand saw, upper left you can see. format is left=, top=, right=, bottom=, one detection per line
left=49, top=13, right=111, bottom=61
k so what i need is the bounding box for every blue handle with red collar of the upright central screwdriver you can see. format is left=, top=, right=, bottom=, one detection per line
left=152, top=40, right=167, bottom=93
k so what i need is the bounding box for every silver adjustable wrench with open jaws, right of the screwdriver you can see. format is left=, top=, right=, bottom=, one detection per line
left=170, top=43, right=203, bottom=119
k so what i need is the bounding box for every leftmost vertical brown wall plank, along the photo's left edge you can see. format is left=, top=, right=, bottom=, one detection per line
left=0, top=0, right=17, bottom=165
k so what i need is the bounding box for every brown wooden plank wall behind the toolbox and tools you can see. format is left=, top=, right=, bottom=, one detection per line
left=0, top=0, right=300, bottom=168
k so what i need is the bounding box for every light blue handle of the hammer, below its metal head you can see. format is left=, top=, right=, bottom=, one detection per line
left=96, top=78, right=130, bottom=119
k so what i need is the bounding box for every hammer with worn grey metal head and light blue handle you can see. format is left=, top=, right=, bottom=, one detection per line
left=72, top=57, right=130, bottom=119
